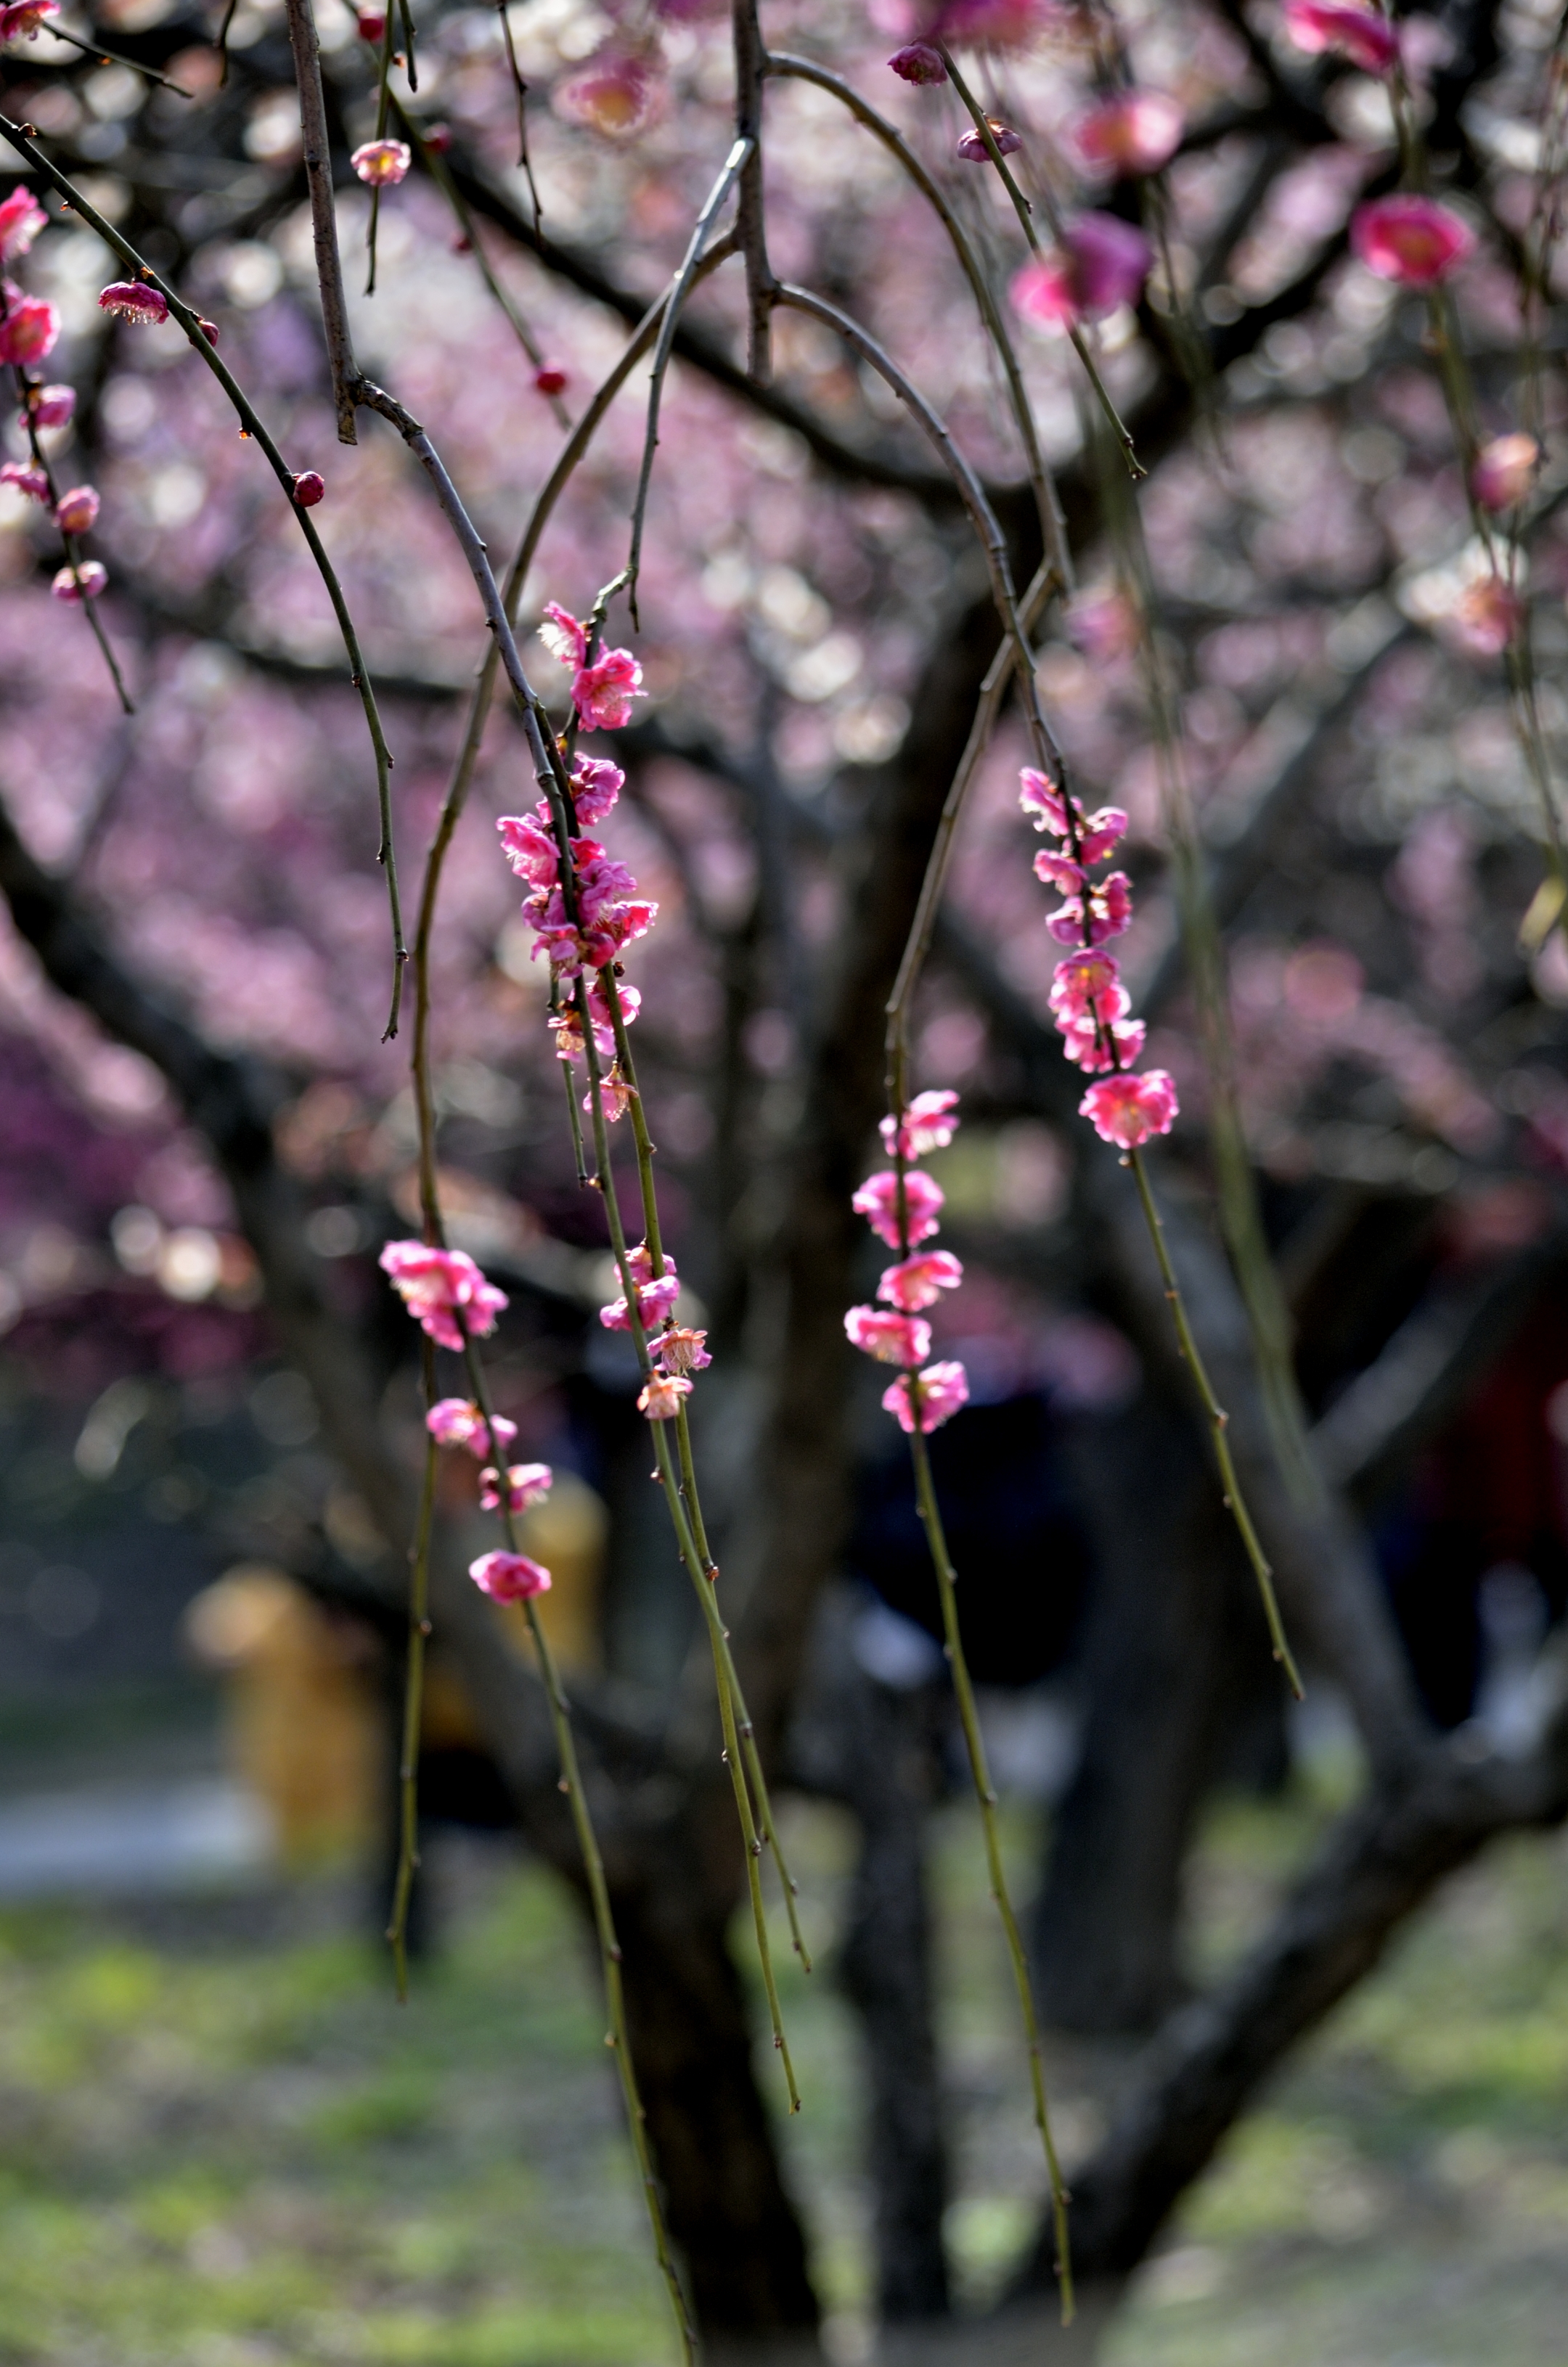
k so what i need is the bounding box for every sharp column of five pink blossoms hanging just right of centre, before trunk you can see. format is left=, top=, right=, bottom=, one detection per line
left=844, top=1091, right=969, bottom=1432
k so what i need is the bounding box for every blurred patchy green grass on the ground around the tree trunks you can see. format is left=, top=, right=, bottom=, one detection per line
left=0, top=1802, right=1568, bottom=2367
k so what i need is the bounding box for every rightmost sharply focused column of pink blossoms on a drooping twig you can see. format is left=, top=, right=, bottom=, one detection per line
left=1018, top=764, right=1180, bottom=1150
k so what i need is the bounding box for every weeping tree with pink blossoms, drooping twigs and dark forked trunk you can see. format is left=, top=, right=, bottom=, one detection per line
left=0, top=0, right=1568, bottom=2348
